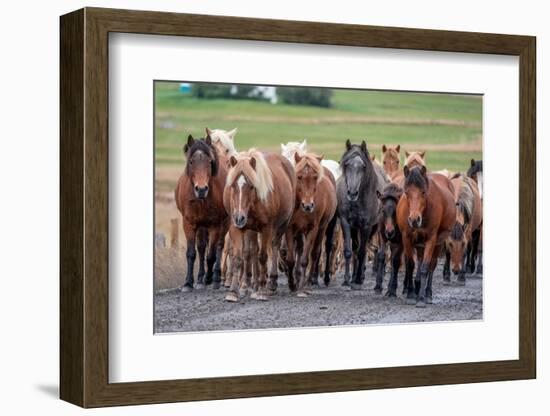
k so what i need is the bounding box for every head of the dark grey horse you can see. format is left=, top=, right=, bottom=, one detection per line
left=340, top=139, right=373, bottom=202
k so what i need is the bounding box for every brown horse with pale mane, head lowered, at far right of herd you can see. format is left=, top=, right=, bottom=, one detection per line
left=443, top=174, right=482, bottom=285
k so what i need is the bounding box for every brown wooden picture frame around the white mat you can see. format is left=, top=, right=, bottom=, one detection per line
left=60, top=8, right=536, bottom=407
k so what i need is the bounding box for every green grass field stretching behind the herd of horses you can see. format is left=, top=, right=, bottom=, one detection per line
left=155, top=82, right=482, bottom=171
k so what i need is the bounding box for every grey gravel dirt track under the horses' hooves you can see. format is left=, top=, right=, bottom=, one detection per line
left=155, top=265, right=483, bottom=333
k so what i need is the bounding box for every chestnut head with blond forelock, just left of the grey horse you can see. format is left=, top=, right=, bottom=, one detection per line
left=294, top=153, right=324, bottom=213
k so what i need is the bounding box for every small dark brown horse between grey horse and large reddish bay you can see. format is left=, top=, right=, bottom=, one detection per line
left=374, top=182, right=403, bottom=297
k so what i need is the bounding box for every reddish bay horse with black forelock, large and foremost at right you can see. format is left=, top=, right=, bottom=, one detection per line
left=397, top=166, right=456, bottom=307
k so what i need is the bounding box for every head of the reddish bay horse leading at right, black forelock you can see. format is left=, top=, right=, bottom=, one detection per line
left=403, top=166, right=429, bottom=228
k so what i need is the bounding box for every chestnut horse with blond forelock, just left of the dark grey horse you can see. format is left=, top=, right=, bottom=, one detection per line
left=285, top=153, right=336, bottom=297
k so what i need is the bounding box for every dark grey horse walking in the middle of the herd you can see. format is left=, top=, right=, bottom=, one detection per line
left=336, top=140, right=387, bottom=289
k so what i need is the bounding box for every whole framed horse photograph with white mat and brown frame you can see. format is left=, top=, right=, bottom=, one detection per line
left=60, top=8, right=536, bottom=407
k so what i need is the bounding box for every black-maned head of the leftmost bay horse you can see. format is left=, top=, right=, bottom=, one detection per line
left=183, top=135, right=218, bottom=199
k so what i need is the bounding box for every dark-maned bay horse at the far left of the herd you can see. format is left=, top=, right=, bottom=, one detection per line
left=174, top=135, right=228, bottom=292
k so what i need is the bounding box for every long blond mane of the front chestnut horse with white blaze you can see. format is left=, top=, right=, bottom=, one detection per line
left=226, top=149, right=273, bottom=202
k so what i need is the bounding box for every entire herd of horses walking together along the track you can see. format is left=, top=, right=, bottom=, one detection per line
left=175, top=128, right=483, bottom=307
